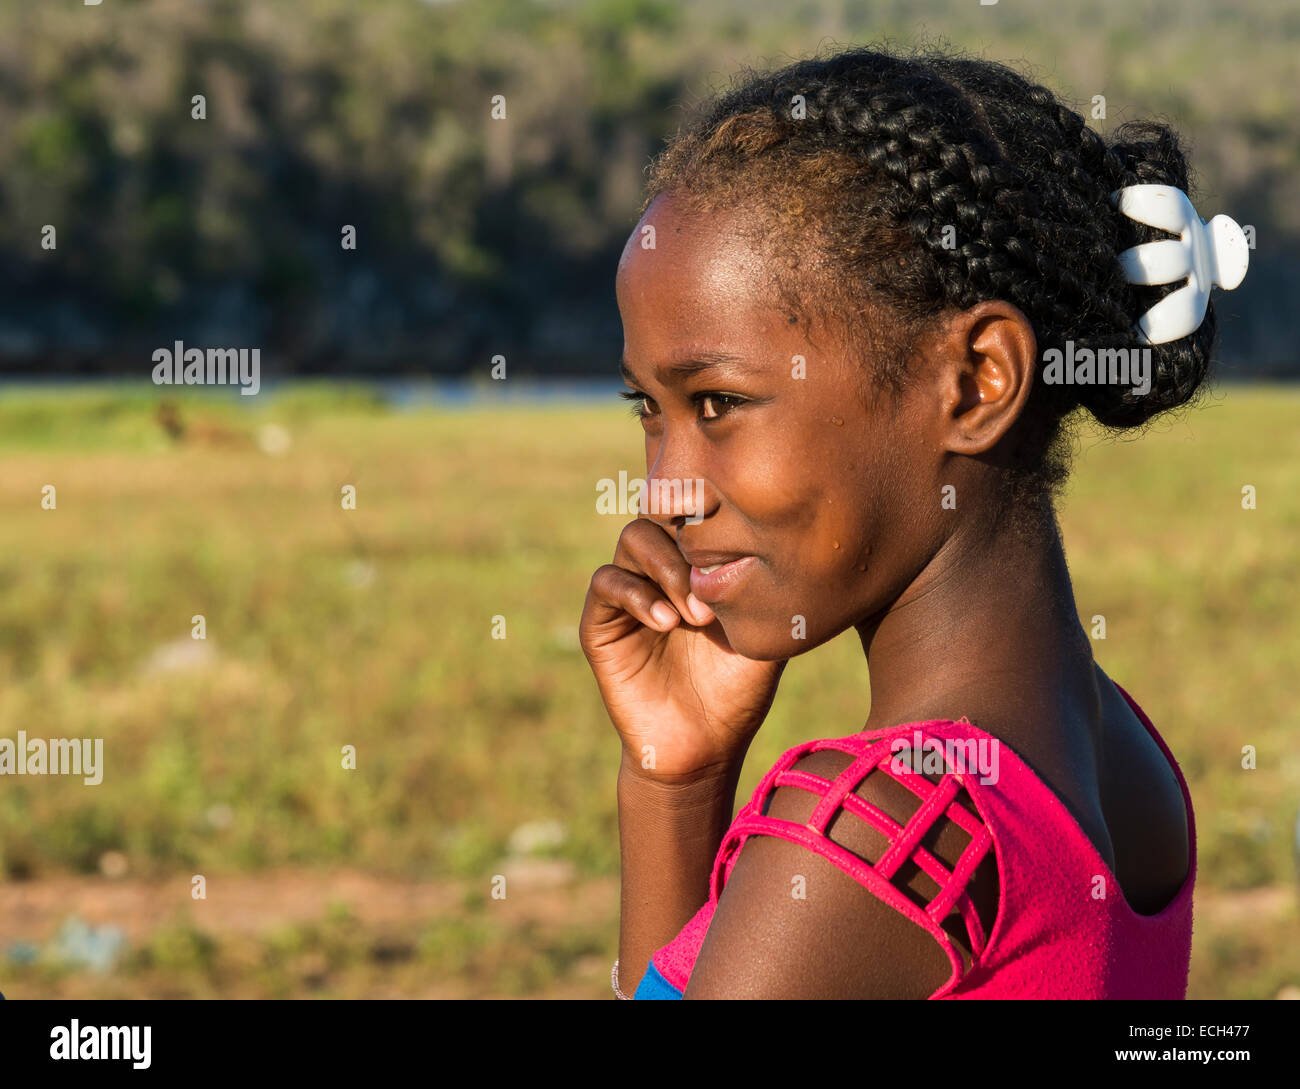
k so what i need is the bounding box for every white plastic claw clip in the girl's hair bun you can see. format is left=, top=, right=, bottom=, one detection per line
left=1110, top=186, right=1251, bottom=344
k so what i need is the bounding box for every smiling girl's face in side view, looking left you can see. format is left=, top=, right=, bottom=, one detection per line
left=616, top=194, right=953, bottom=660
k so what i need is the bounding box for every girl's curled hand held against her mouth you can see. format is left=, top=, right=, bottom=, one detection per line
left=579, top=517, right=785, bottom=782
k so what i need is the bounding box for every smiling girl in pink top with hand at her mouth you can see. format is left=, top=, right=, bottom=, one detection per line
left=580, top=49, right=1235, bottom=998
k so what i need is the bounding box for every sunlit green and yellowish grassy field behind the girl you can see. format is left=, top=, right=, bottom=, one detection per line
left=0, top=386, right=1300, bottom=998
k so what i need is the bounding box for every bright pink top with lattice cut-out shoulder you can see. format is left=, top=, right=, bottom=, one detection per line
left=647, top=685, right=1196, bottom=998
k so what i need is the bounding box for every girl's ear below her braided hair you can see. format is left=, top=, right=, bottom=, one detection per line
left=933, top=299, right=1037, bottom=455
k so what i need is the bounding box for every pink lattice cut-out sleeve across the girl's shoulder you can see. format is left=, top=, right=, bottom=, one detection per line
left=710, top=720, right=1005, bottom=997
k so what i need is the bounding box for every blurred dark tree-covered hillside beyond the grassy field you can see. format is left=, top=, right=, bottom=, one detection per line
left=0, top=0, right=1300, bottom=377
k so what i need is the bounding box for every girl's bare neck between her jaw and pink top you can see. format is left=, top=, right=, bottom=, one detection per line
left=858, top=504, right=1100, bottom=736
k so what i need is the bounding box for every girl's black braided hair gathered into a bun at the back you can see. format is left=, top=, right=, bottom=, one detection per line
left=641, top=48, right=1216, bottom=506
